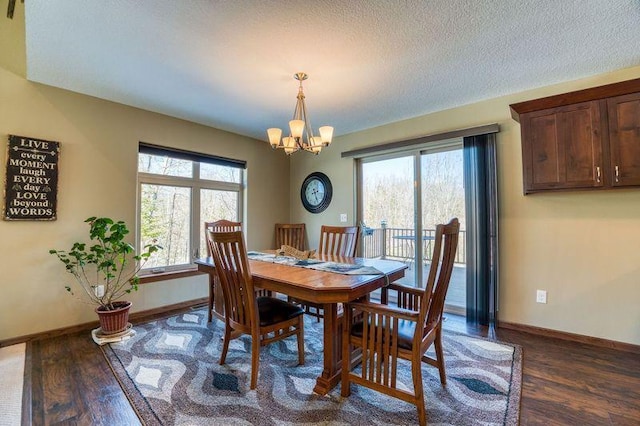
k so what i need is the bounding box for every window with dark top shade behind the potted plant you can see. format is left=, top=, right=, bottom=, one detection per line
left=138, top=142, right=245, bottom=272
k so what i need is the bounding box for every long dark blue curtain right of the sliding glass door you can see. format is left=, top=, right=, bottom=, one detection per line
left=463, top=133, right=498, bottom=326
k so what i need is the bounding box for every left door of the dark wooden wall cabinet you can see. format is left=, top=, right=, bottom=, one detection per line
left=521, top=101, right=604, bottom=193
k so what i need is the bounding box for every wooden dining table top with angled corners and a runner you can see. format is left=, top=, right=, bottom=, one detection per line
left=196, top=250, right=407, bottom=303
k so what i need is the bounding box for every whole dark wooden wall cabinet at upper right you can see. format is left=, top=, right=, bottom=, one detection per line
left=510, top=79, right=640, bottom=194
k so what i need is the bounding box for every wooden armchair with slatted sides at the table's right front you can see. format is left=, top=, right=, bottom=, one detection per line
left=341, top=218, right=460, bottom=426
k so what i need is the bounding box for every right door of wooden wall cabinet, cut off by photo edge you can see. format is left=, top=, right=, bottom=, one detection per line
left=607, top=93, right=640, bottom=186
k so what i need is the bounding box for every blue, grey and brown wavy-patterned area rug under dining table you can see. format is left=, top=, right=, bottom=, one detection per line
left=102, top=309, right=522, bottom=426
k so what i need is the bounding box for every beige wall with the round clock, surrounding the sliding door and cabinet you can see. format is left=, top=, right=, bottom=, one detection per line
left=291, top=67, right=640, bottom=344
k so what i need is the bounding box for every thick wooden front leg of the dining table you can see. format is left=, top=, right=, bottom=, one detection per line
left=313, top=303, right=342, bottom=395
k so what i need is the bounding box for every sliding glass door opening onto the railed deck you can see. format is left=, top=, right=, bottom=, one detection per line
left=358, top=141, right=466, bottom=315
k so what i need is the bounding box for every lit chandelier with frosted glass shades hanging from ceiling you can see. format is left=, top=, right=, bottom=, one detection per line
left=267, top=72, right=333, bottom=154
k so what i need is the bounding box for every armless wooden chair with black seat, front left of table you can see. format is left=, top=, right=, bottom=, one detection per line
left=209, top=231, right=304, bottom=389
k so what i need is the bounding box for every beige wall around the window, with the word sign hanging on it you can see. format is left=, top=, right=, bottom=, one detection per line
left=0, top=1, right=289, bottom=341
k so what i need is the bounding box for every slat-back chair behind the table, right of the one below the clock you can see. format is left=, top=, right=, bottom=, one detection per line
left=288, top=225, right=360, bottom=321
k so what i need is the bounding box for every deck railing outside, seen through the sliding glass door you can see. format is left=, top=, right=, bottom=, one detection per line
left=361, top=224, right=467, bottom=264
